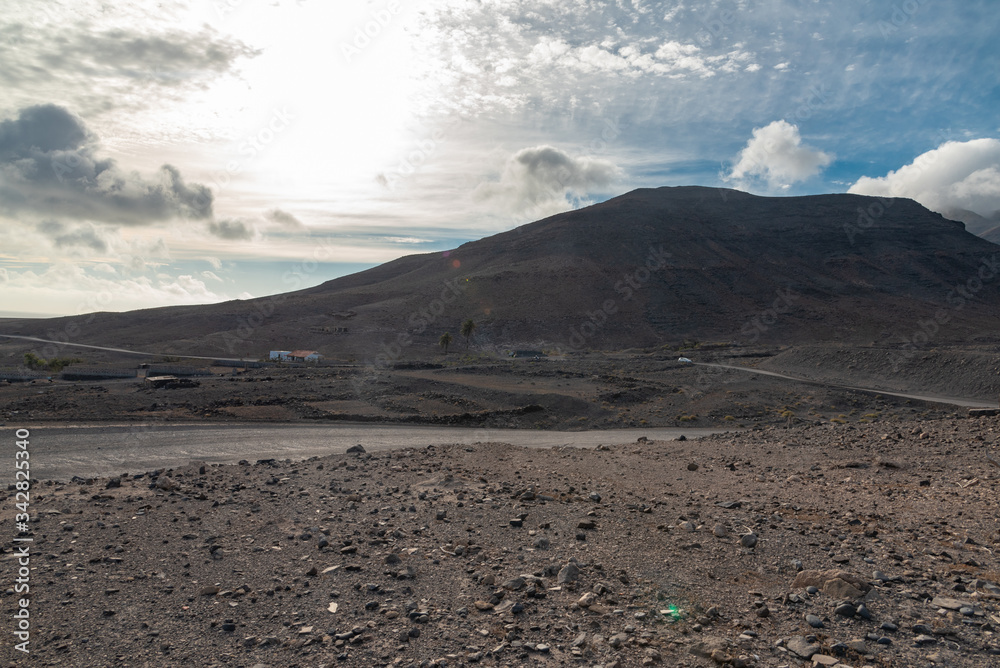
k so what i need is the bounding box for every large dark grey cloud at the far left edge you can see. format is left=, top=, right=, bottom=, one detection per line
left=0, top=104, right=213, bottom=225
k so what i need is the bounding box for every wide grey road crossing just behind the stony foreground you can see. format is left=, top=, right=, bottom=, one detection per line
left=0, top=423, right=726, bottom=486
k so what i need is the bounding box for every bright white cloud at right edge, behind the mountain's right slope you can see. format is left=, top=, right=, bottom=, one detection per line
left=848, top=138, right=1000, bottom=216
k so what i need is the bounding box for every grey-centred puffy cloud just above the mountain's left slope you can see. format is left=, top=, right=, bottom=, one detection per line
left=474, top=146, right=621, bottom=217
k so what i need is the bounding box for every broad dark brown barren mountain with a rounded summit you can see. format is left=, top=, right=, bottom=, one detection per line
left=0, top=187, right=1000, bottom=359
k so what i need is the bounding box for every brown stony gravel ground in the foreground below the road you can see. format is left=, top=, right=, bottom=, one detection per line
left=0, top=417, right=1000, bottom=668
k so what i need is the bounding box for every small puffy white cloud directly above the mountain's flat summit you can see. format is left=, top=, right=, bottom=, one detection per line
left=728, top=120, right=833, bottom=188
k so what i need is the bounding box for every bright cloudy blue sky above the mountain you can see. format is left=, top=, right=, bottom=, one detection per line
left=0, top=0, right=1000, bottom=316
